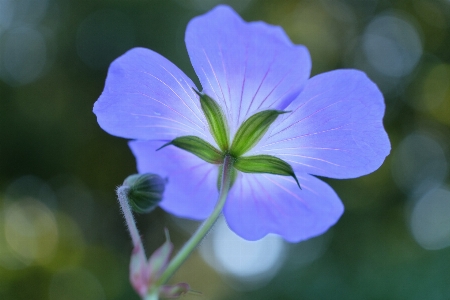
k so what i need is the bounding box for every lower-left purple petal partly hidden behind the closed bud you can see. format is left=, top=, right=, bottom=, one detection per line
left=129, top=141, right=219, bottom=219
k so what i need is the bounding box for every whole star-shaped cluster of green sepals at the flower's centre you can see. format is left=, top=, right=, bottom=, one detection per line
left=157, top=89, right=300, bottom=190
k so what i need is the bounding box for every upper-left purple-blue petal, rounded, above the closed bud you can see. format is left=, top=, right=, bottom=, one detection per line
left=94, top=48, right=211, bottom=140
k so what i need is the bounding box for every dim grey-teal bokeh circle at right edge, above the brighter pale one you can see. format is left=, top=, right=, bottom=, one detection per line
left=391, top=133, right=447, bottom=194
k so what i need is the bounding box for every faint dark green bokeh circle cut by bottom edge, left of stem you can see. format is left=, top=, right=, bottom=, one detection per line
left=49, top=268, right=105, bottom=300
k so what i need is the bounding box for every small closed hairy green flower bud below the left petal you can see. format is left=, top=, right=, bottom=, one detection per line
left=123, top=173, right=167, bottom=213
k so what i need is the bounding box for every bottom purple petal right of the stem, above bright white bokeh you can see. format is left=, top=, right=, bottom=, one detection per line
left=224, top=173, right=344, bottom=242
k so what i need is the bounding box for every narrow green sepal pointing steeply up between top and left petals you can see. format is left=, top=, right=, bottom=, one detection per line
left=194, top=89, right=229, bottom=151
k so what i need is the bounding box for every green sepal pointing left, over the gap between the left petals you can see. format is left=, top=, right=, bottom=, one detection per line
left=157, top=135, right=223, bottom=164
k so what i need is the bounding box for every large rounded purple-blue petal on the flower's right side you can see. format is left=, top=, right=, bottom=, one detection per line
left=253, top=70, right=391, bottom=178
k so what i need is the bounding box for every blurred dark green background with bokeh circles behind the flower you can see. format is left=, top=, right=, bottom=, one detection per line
left=0, top=0, right=450, bottom=300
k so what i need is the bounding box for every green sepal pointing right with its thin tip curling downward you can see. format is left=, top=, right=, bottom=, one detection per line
left=233, top=155, right=301, bottom=189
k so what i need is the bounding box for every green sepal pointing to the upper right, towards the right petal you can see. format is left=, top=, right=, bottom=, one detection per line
left=230, top=110, right=286, bottom=157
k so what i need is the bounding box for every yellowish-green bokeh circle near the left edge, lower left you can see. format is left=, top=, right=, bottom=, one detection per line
left=4, top=198, right=58, bottom=265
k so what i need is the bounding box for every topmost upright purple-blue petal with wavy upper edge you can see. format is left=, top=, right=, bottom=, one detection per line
left=185, top=5, right=311, bottom=134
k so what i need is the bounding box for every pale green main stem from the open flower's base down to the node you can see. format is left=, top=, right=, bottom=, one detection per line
left=158, top=155, right=233, bottom=285
